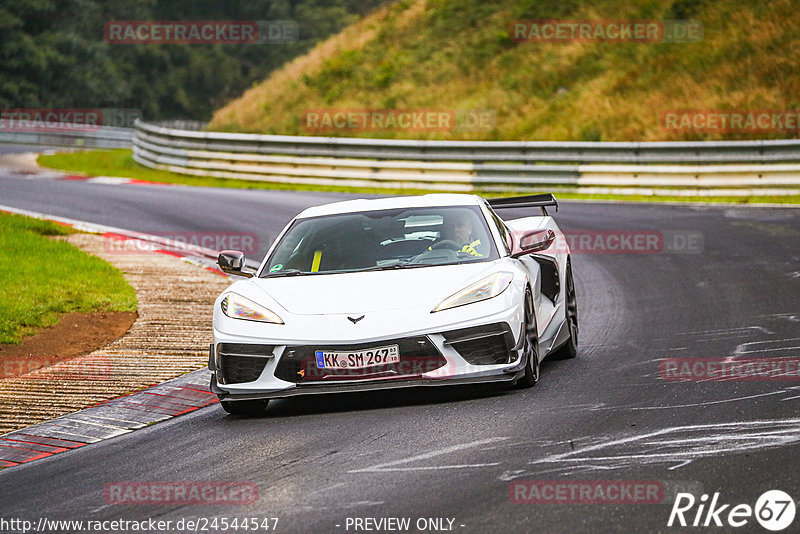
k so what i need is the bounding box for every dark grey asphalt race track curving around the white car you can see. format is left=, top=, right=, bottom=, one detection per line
left=0, top=171, right=800, bottom=532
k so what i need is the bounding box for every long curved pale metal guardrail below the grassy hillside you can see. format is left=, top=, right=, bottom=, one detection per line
left=134, top=121, right=800, bottom=194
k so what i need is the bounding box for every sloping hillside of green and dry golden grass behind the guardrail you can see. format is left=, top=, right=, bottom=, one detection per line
left=210, top=0, right=800, bottom=141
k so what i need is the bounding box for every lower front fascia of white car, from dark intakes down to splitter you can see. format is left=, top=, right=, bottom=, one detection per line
left=209, top=322, right=524, bottom=400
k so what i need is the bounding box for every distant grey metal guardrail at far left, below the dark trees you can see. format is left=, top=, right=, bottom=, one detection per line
left=0, top=126, right=134, bottom=148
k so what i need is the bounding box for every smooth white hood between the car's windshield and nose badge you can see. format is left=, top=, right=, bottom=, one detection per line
left=249, top=262, right=497, bottom=315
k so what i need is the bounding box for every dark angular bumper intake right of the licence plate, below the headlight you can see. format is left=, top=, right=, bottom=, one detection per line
left=442, top=323, right=514, bottom=365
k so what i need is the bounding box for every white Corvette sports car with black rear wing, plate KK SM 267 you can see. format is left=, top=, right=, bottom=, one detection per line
left=208, top=194, right=578, bottom=414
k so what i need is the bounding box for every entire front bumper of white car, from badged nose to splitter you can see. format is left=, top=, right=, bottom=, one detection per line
left=209, top=286, right=524, bottom=400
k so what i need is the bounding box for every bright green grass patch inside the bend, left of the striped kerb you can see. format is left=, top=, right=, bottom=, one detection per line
left=0, top=213, right=137, bottom=344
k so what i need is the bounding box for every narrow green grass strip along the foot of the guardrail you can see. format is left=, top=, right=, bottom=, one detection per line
left=37, top=149, right=800, bottom=204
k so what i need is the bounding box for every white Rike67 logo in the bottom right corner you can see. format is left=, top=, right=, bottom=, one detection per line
left=667, top=490, right=795, bottom=532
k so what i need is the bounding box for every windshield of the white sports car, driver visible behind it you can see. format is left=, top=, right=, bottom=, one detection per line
left=260, top=206, right=498, bottom=277
